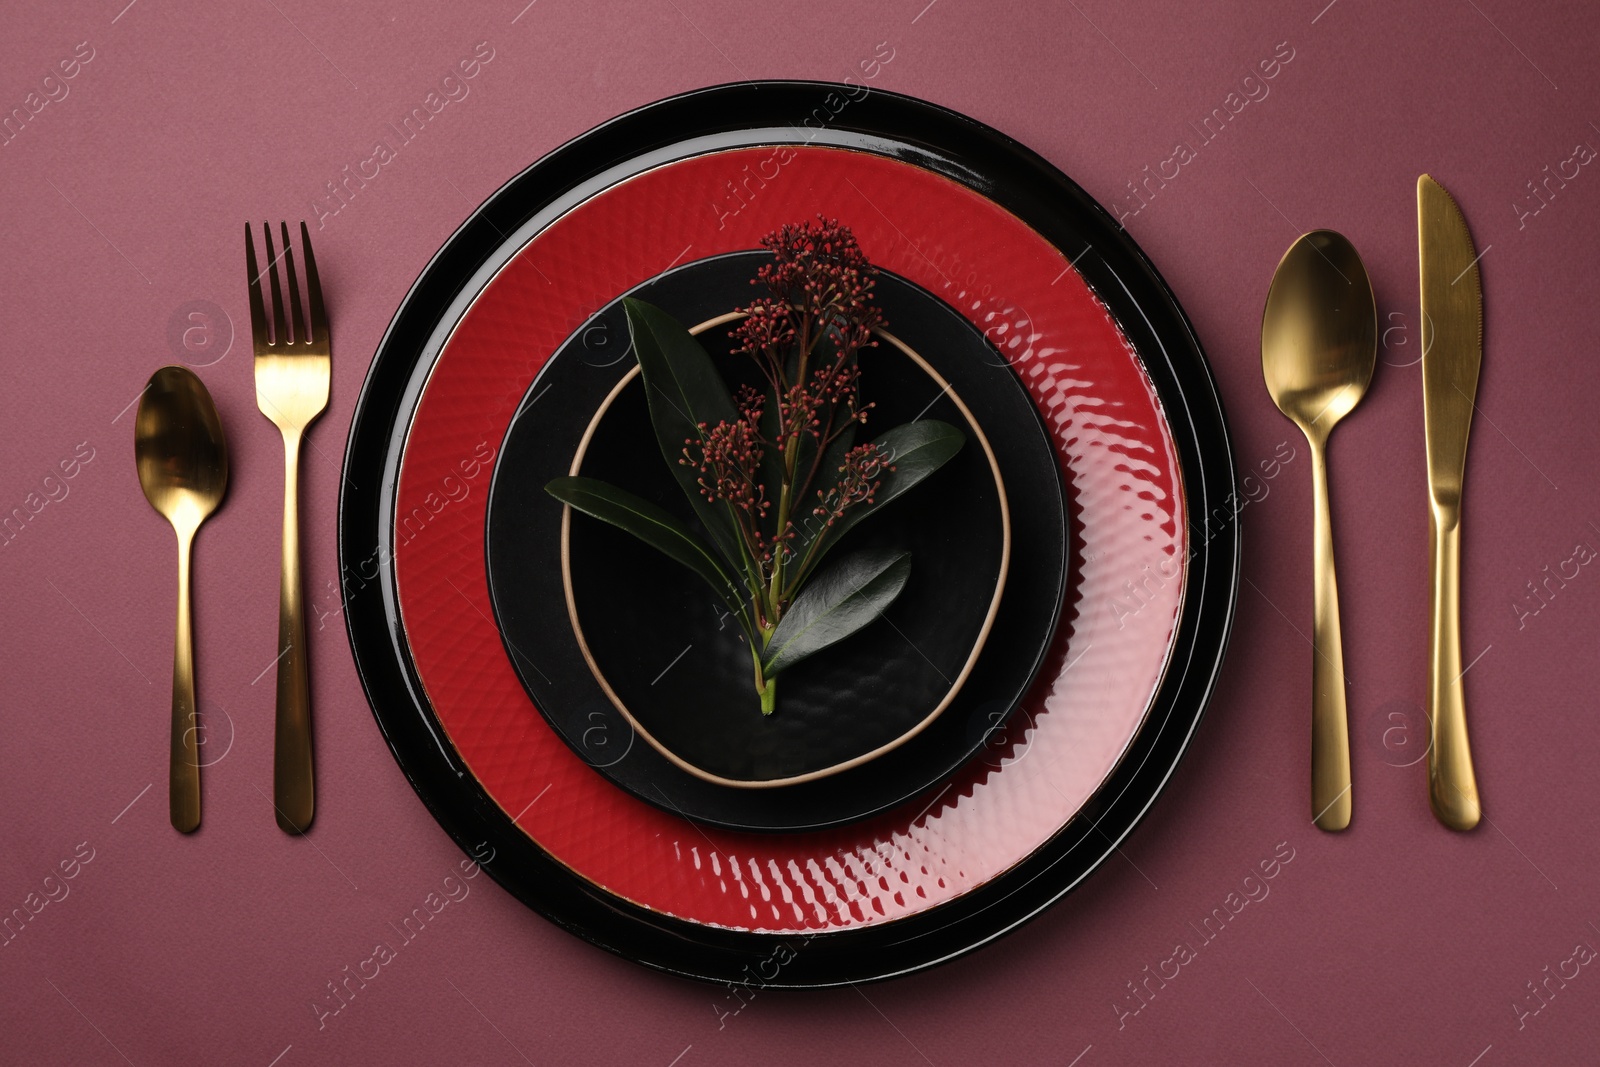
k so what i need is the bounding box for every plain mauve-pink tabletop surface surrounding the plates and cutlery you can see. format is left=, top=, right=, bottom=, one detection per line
left=0, top=0, right=1600, bottom=1067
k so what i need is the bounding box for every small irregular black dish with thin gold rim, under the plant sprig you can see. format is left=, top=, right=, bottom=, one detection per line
left=570, top=303, right=1010, bottom=787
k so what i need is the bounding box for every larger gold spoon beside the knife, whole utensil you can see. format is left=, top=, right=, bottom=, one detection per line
left=1261, top=230, right=1378, bottom=830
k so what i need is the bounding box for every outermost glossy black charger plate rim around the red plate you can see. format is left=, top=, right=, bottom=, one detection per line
left=339, top=82, right=1240, bottom=987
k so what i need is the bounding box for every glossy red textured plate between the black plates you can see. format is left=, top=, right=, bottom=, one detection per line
left=395, top=146, right=1187, bottom=933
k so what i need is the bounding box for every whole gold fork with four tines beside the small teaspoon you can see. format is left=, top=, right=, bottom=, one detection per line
left=245, top=222, right=330, bottom=833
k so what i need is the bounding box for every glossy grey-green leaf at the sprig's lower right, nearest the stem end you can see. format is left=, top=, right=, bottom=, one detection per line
left=762, top=549, right=910, bottom=677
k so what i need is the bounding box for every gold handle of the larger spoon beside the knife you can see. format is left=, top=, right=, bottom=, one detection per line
left=1310, top=440, right=1350, bottom=830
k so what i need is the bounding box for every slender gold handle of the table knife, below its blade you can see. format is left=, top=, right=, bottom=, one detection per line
left=1427, top=506, right=1480, bottom=830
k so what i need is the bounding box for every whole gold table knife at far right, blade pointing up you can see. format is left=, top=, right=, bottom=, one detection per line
left=1416, top=174, right=1483, bottom=830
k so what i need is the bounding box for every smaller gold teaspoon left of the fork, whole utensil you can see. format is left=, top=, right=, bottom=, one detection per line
left=133, top=366, right=227, bottom=833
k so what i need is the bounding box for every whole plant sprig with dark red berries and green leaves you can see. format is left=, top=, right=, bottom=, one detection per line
left=546, top=219, right=965, bottom=715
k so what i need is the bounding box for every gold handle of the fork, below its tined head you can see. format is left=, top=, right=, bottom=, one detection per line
left=272, top=430, right=315, bottom=833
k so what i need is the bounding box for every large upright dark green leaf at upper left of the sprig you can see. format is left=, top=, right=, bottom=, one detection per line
left=622, top=298, right=746, bottom=566
